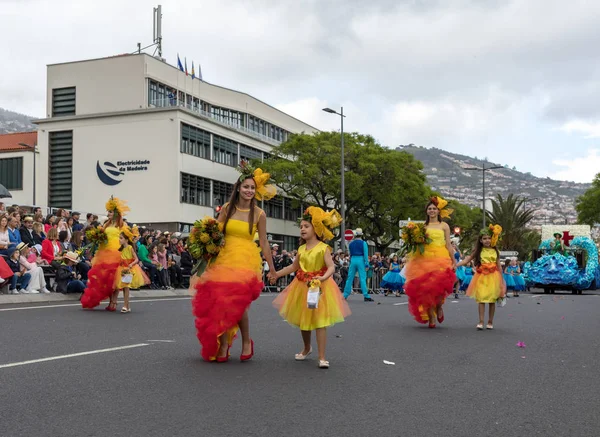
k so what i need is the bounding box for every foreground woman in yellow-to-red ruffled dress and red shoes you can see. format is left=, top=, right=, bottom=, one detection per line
left=191, top=162, right=276, bottom=363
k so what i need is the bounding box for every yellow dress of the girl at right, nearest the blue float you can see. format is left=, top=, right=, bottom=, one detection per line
left=467, top=247, right=506, bottom=303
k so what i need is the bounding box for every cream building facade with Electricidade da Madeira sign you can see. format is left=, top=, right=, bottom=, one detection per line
left=37, top=54, right=316, bottom=249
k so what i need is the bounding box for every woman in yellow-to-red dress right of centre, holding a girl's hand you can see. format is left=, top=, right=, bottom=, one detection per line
left=404, top=197, right=456, bottom=328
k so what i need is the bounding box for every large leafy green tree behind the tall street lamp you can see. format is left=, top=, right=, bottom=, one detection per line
left=263, top=132, right=429, bottom=251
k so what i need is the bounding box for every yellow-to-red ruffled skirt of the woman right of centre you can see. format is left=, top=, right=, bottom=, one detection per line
left=404, top=244, right=456, bottom=323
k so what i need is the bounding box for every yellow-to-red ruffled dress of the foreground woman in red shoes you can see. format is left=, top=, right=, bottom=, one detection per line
left=191, top=233, right=264, bottom=361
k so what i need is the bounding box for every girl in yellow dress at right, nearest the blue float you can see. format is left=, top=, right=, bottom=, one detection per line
left=458, top=225, right=506, bottom=330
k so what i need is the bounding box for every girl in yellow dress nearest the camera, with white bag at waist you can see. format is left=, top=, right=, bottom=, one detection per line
left=271, top=206, right=350, bottom=369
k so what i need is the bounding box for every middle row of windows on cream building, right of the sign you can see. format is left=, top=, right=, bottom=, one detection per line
left=180, top=123, right=263, bottom=167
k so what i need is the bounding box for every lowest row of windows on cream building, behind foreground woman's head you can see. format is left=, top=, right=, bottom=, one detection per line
left=181, top=173, right=304, bottom=221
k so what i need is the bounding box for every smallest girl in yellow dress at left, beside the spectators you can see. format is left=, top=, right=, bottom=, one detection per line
left=111, top=226, right=150, bottom=314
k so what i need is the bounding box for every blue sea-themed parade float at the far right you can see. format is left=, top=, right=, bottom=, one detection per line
left=523, top=225, right=600, bottom=294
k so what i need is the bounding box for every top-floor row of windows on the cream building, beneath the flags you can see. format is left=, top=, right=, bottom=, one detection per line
left=148, top=79, right=288, bottom=142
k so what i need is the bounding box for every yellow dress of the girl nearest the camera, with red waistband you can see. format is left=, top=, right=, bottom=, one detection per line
left=273, top=242, right=351, bottom=331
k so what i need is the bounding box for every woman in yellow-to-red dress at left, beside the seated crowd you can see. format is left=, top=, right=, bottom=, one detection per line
left=81, top=196, right=129, bottom=311
